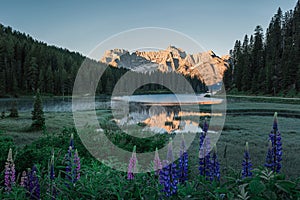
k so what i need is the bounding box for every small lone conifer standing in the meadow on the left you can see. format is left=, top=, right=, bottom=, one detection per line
left=31, top=89, right=45, bottom=129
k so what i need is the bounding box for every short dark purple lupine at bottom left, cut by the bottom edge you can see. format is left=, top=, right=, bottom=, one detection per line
left=26, top=165, right=40, bottom=199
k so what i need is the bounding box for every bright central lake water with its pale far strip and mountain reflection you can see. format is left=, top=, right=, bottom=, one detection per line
left=111, top=94, right=222, bottom=133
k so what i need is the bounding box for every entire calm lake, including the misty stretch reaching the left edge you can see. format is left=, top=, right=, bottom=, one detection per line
left=0, top=94, right=222, bottom=133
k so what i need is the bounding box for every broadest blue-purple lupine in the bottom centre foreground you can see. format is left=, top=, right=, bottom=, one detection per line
left=159, top=139, right=178, bottom=197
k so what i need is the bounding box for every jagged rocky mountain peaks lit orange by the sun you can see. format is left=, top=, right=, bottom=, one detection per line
left=100, top=46, right=229, bottom=85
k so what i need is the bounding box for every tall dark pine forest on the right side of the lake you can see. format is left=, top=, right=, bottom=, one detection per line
left=224, top=1, right=300, bottom=96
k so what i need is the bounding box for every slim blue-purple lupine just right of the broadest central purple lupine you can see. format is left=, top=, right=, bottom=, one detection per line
left=178, top=134, right=188, bottom=184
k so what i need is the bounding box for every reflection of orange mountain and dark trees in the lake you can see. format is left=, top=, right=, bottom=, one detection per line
left=113, top=94, right=222, bottom=133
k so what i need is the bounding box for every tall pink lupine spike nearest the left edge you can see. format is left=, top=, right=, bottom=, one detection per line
left=4, top=148, right=16, bottom=192
